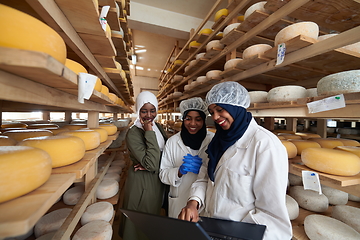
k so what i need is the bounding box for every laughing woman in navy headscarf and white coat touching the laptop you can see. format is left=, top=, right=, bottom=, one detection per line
left=179, top=82, right=292, bottom=240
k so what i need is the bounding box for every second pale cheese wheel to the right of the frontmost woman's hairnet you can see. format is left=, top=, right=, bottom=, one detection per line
left=267, top=85, right=306, bottom=102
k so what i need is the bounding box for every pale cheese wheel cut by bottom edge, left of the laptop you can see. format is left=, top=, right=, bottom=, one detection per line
left=72, top=220, right=113, bottom=240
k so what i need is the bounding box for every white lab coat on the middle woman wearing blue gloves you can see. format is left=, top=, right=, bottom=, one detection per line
left=159, top=131, right=214, bottom=218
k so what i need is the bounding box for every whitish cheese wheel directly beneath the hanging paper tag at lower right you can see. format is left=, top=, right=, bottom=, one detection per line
left=289, top=186, right=329, bottom=212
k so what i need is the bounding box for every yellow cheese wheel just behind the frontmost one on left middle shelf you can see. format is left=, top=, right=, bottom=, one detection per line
left=17, top=136, right=85, bottom=168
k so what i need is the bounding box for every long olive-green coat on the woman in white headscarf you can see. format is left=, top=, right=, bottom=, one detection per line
left=120, top=123, right=167, bottom=240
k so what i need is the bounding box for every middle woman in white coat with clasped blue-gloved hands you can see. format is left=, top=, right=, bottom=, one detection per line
left=159, top=97, right=214, bottom=218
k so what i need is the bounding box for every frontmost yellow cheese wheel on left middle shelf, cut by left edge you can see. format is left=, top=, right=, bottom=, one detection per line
left=0, top=146, right=51, bottom=203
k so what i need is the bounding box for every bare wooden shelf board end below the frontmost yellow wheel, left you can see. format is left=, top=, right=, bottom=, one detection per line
left=0, top=173, right=75, bottom=238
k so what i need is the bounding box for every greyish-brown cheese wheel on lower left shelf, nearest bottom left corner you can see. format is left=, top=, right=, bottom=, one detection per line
left=34, top=208, right=72, bottom=237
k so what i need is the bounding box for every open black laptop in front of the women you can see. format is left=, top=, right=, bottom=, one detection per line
left=120, top=209, right=266, bottom=240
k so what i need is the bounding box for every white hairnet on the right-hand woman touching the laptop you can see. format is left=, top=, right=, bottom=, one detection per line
left=205, top=82, right=250, bottom=108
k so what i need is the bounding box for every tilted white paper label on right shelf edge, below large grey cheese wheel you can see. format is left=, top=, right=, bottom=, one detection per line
left=307, top=94, right=346, bottom=113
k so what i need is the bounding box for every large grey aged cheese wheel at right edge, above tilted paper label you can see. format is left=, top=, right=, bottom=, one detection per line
left=317, top=70, right=360, bottom=96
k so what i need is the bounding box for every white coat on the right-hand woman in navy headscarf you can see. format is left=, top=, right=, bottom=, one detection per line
left=189, top=119, right=292, bottom=240
